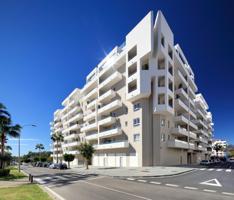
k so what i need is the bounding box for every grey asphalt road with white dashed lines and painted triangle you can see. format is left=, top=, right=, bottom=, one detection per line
left=24, top=164, right=234, bottom=200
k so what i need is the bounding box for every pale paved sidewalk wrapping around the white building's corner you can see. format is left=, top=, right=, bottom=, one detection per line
left=71, top=166, right=195, bottom=177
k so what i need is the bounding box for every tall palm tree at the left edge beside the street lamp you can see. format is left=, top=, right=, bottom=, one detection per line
left=0, top=103, right=21, bottom=169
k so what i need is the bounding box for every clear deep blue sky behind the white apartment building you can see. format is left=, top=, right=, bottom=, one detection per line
left=0, top=0, right=234, bottom=155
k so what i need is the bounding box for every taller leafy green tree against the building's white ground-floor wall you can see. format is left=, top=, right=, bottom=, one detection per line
left=78, top=142, right=95, bottom=169
